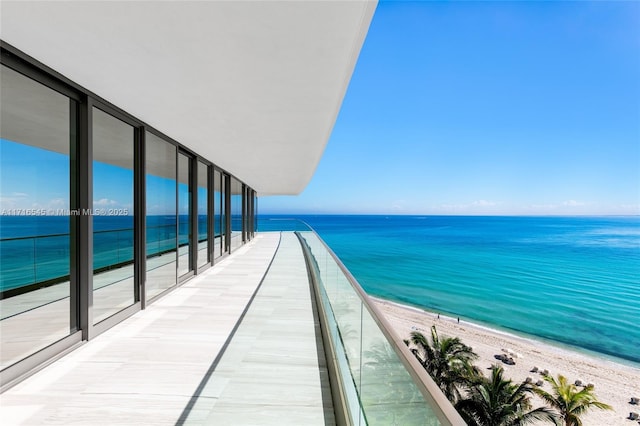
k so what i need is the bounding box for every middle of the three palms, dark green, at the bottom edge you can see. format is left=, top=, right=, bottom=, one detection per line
left=456, top=365, right=555, bottom=426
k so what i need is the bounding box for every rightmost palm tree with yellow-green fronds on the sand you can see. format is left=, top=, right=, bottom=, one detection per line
left=535, top=375, right=612, bottom=426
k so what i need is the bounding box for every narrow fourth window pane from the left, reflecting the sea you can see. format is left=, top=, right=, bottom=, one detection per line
left=178, top=154, right=191, bottom=277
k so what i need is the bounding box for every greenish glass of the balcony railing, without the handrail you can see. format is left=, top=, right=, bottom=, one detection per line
left=301, top=231, right=440, bottom=425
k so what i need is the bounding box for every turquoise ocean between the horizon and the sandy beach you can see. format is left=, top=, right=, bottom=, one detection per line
left=258, top=216, right=640, bottom=363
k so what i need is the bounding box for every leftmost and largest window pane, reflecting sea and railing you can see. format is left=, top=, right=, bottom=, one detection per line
left=0, top=66, right=77, bottom=369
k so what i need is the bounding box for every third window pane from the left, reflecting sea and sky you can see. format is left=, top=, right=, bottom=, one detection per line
left=145, top=132, right=178, bottom=300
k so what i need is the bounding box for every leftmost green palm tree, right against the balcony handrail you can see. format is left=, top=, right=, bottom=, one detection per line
left=405, top=325, right=479, bottom=403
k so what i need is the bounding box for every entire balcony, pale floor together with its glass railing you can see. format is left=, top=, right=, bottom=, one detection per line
left=0, top=224, right=463, bottom=425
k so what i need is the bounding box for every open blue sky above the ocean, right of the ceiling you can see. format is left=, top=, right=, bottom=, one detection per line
left=259, top=1, right=640, bottom=215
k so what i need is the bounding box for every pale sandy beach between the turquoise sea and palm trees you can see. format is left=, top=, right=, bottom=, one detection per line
left=372, top=298, right=640, bottom=426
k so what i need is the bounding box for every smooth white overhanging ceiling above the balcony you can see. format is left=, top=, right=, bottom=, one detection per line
left=0, top=0, right=376, bottom=195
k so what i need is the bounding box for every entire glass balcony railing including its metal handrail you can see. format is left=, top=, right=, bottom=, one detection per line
left=286, top=225, right=464, bottom=426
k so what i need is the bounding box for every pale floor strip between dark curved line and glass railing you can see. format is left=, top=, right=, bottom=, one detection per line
left=178, top=233, right=335, bottom=425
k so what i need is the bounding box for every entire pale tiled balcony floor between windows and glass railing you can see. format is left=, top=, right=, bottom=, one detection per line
left=0, top=233, right=335, bottom=425
